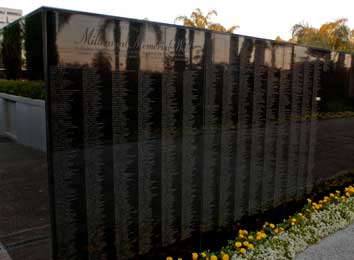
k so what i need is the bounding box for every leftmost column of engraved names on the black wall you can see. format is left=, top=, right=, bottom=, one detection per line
left=49, top=67, right=87, bottom=259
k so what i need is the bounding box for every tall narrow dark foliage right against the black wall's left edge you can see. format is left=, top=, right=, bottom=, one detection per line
left=24, top=13, right=44, bottom=80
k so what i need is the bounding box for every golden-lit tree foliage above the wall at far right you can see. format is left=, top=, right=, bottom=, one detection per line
left=290, top=18, right=354, bottom=51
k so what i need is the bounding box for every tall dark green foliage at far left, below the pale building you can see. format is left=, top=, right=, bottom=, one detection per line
left=2, top=22, right=22, bottom=79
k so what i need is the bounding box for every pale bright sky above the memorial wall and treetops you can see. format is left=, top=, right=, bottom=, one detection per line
left=0, top=0, right=354, bottom=40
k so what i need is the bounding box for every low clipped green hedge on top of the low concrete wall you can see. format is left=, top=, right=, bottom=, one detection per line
left=0, top=80, right=45, bottom=99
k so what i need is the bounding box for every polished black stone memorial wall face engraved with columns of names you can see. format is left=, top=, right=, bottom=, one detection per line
left=17, top=8, right=354, bottom=260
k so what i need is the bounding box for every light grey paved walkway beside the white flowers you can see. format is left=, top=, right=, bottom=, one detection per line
left=295, top=223, right=354, bottom=260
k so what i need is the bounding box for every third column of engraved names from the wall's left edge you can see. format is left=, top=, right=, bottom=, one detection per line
left=112, top=71, right=139, bottom=259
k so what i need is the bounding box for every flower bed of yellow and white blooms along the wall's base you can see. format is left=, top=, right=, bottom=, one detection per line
left=167, top=172, right=354, bottom=260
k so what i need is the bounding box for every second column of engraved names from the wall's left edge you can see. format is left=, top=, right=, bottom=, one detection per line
left=82, top=68, right=109, bottom=259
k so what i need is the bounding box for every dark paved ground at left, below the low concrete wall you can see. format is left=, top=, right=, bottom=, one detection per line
left=0, top=135, right=50, bottom=260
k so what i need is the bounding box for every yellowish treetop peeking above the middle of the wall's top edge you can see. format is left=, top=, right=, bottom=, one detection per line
left=175, top=8, right=239, bottom=33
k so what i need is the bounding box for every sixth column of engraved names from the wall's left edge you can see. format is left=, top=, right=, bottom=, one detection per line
left=181, top=68, right=203, bottom=239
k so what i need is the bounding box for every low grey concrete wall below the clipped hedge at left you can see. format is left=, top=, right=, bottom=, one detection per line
left=0, top=93, right=47, bottom=151
